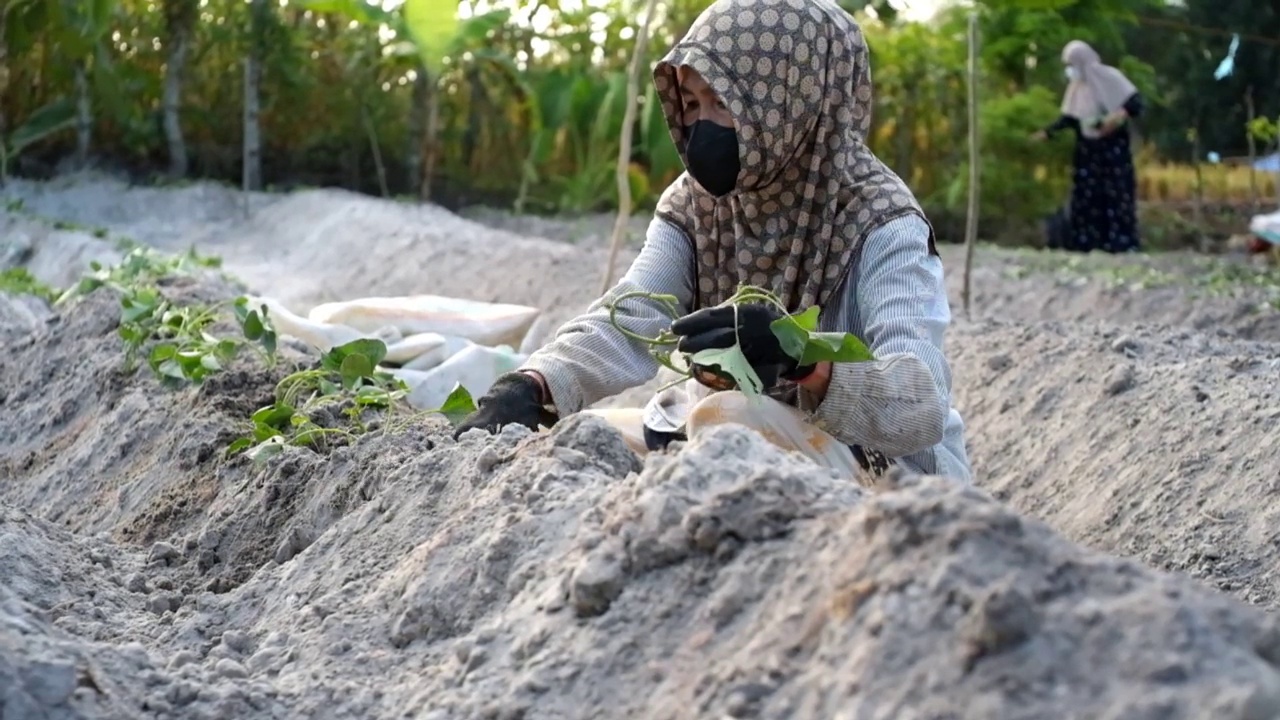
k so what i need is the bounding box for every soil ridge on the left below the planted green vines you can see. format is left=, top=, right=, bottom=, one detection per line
left=0, top=278, right=419, bottom=599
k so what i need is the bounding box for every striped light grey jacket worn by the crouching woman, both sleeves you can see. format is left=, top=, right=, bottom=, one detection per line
left=522, top=215, right=972, bottom=483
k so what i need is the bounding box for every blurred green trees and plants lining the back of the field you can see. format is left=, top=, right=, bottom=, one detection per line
left=0, top=0, right=1280, bottom=242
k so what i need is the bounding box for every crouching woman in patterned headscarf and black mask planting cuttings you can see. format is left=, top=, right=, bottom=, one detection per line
left=458, top=0, right=970, bottom=480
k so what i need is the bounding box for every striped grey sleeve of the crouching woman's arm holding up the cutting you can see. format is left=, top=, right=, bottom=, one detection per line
left=815, top=215, right=951, bottom=457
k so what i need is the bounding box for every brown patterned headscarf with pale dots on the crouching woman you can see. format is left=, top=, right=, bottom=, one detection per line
left=654, top=0, right=937, bottom=311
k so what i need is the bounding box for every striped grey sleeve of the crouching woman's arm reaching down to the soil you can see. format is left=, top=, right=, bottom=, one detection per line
left=520, top=218, right=694, bottom=416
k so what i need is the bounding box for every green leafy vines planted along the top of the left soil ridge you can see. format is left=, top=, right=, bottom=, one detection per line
left=28, top=240, right=476, bottom=461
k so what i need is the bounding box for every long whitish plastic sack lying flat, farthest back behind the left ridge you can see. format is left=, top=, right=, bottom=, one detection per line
left=308, top=295, right=540, bottom=347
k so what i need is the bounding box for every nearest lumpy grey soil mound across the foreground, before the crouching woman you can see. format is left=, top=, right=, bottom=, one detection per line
left=0, top=397, right=1280, bottom=719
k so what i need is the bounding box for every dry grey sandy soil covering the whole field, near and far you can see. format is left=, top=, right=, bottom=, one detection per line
left=0, top=170, right=1280, bottom=720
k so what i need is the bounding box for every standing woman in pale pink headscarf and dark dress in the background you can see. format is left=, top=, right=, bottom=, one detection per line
left=1036, top=40, right=1142, bottom=252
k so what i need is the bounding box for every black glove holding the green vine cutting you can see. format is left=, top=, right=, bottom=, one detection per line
left=671, top=304, right=814, bottom=388
